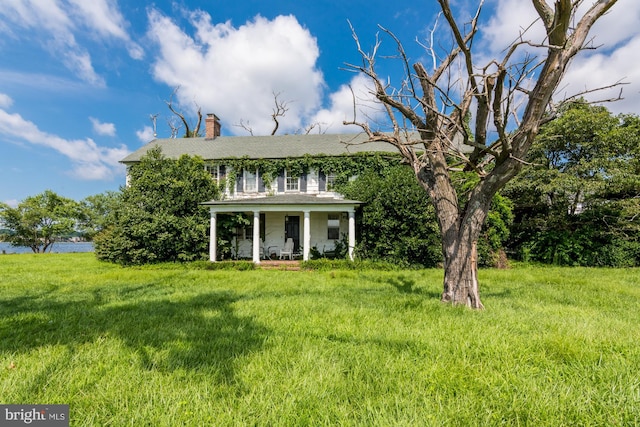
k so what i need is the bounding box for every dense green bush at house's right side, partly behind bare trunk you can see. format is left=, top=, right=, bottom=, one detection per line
left=338, top=165, right=512, bottom=267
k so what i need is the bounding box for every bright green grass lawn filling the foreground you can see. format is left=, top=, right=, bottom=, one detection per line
left=0, top=254, right=640, bottom=426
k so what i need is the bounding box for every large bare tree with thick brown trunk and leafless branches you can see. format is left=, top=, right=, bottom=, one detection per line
left=345, top=0, right=616, bottom=309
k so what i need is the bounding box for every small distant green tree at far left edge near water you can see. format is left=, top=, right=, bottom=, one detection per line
left=0, top=190, right=78, bottom=253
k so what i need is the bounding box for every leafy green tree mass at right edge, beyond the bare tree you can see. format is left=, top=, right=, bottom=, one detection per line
left=504, top=101, right=640, bottom=266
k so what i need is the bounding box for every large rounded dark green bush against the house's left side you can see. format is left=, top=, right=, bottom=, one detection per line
left=94, top=148, right=218, bottom=265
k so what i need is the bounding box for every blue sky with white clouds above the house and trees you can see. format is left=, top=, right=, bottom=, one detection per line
left=0, top=0, right=640, bottom=205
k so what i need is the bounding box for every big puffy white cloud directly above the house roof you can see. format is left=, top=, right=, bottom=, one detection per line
left=149, top=9, right=324, bottom=134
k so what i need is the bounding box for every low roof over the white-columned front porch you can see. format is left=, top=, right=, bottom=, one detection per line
left=201, top=194, right=363, bottom=212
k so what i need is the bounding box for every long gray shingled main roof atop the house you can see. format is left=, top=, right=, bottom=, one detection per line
left=120, top=134, right=397, bottom=164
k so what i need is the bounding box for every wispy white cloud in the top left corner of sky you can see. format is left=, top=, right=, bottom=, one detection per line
left=0, top=0, right=143, bottom=87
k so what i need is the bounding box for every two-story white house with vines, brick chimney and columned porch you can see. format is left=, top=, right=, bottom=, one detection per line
left=121, top=114, right=397, bottom=263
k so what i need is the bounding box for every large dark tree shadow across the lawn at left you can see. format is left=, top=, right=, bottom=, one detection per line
left=0, top=286, right=268, bottom=382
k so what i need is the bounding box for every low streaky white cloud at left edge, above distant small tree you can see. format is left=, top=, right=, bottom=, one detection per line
left=0, top=109, right=129, bottom=180
